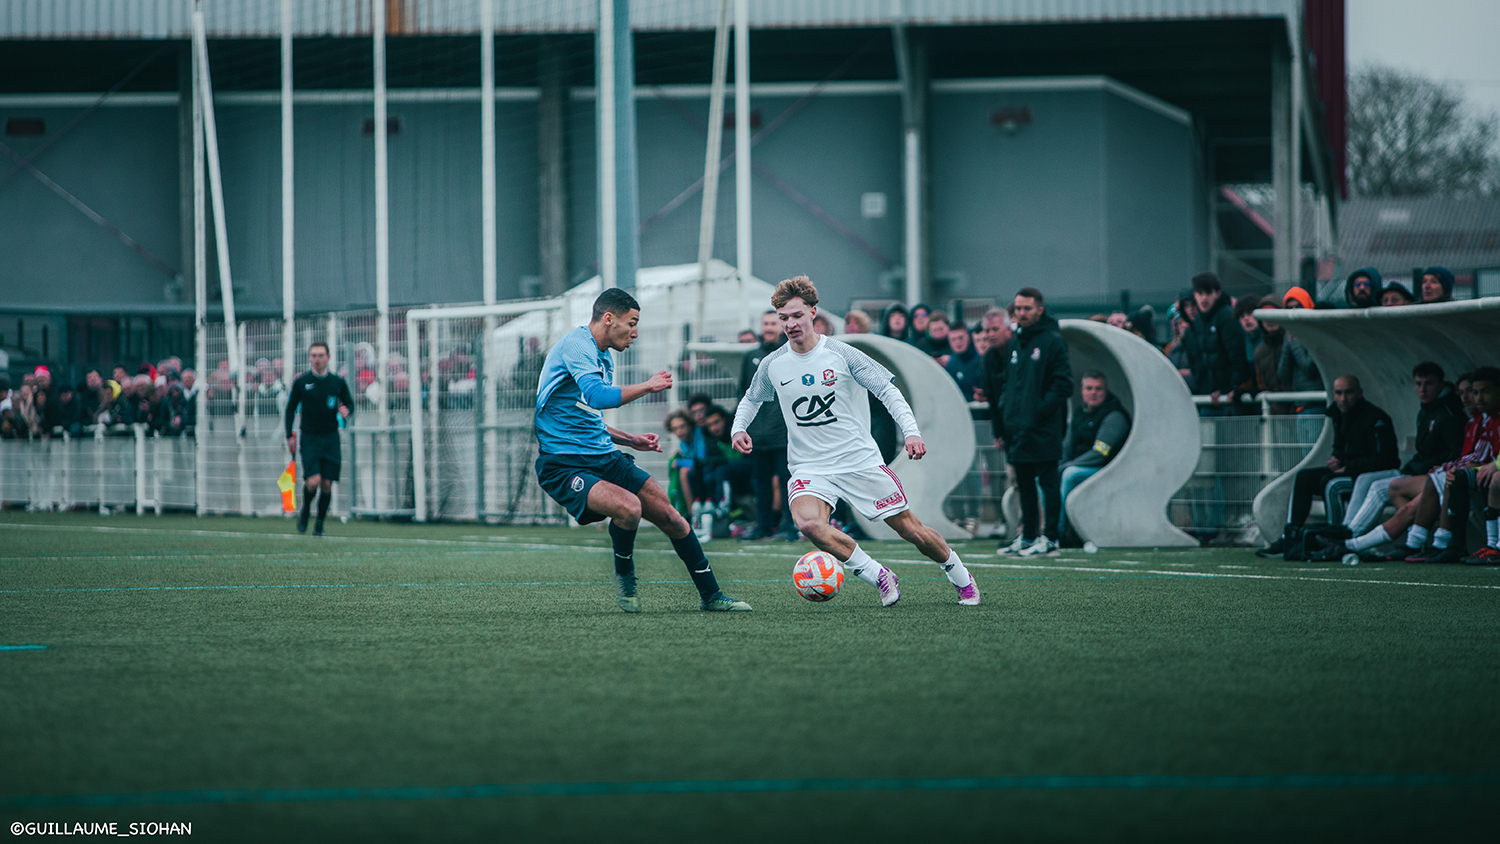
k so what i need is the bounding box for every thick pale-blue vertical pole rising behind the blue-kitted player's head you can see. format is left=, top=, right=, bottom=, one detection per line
left=594, top=0, right=641, bottom=289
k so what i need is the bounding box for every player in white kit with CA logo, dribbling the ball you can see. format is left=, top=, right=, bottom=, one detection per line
left=732, top=276, right=980, bottom=607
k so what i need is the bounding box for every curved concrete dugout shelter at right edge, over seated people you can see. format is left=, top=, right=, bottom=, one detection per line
left=1256, top=297, right=1500, bottom=541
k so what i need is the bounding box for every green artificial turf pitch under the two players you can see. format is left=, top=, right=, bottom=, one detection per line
left=0, top=511, right=1500, bottom=841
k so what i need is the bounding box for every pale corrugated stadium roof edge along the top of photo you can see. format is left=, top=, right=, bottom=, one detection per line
left=0, top=0, right=1302, bottom=39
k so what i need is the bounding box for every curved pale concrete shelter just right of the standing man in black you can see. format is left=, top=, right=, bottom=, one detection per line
left=1053, top=319, right=1200, bottom=547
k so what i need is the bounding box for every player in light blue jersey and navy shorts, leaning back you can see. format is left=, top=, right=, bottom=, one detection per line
left=536, top=288, right=750, bottom=613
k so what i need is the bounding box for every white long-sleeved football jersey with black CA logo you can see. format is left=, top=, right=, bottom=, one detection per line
left=735, top=337, right=920, bottom=474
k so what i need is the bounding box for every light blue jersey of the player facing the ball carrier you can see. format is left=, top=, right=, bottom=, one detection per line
left=536, top=325, right=620, bottom=454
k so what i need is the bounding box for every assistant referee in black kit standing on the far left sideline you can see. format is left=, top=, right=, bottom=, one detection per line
left=287, top=342, right=354, bottom=537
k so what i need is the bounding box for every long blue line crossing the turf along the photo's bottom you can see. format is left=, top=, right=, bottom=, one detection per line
left=0, top=774, right=1500, bottom=808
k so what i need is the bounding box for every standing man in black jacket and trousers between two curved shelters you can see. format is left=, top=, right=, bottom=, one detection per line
left=986, top=288, right=1073, bottom=556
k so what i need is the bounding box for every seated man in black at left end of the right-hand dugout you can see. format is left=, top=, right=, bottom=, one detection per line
left=1256, top=375, right=1401, bottom=556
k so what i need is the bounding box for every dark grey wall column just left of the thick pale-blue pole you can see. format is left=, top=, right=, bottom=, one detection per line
left=537, top=36, right=567, bottom=297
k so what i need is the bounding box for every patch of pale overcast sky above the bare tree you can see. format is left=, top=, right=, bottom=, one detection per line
left=1344, top=0, right=1500, bottom=120
